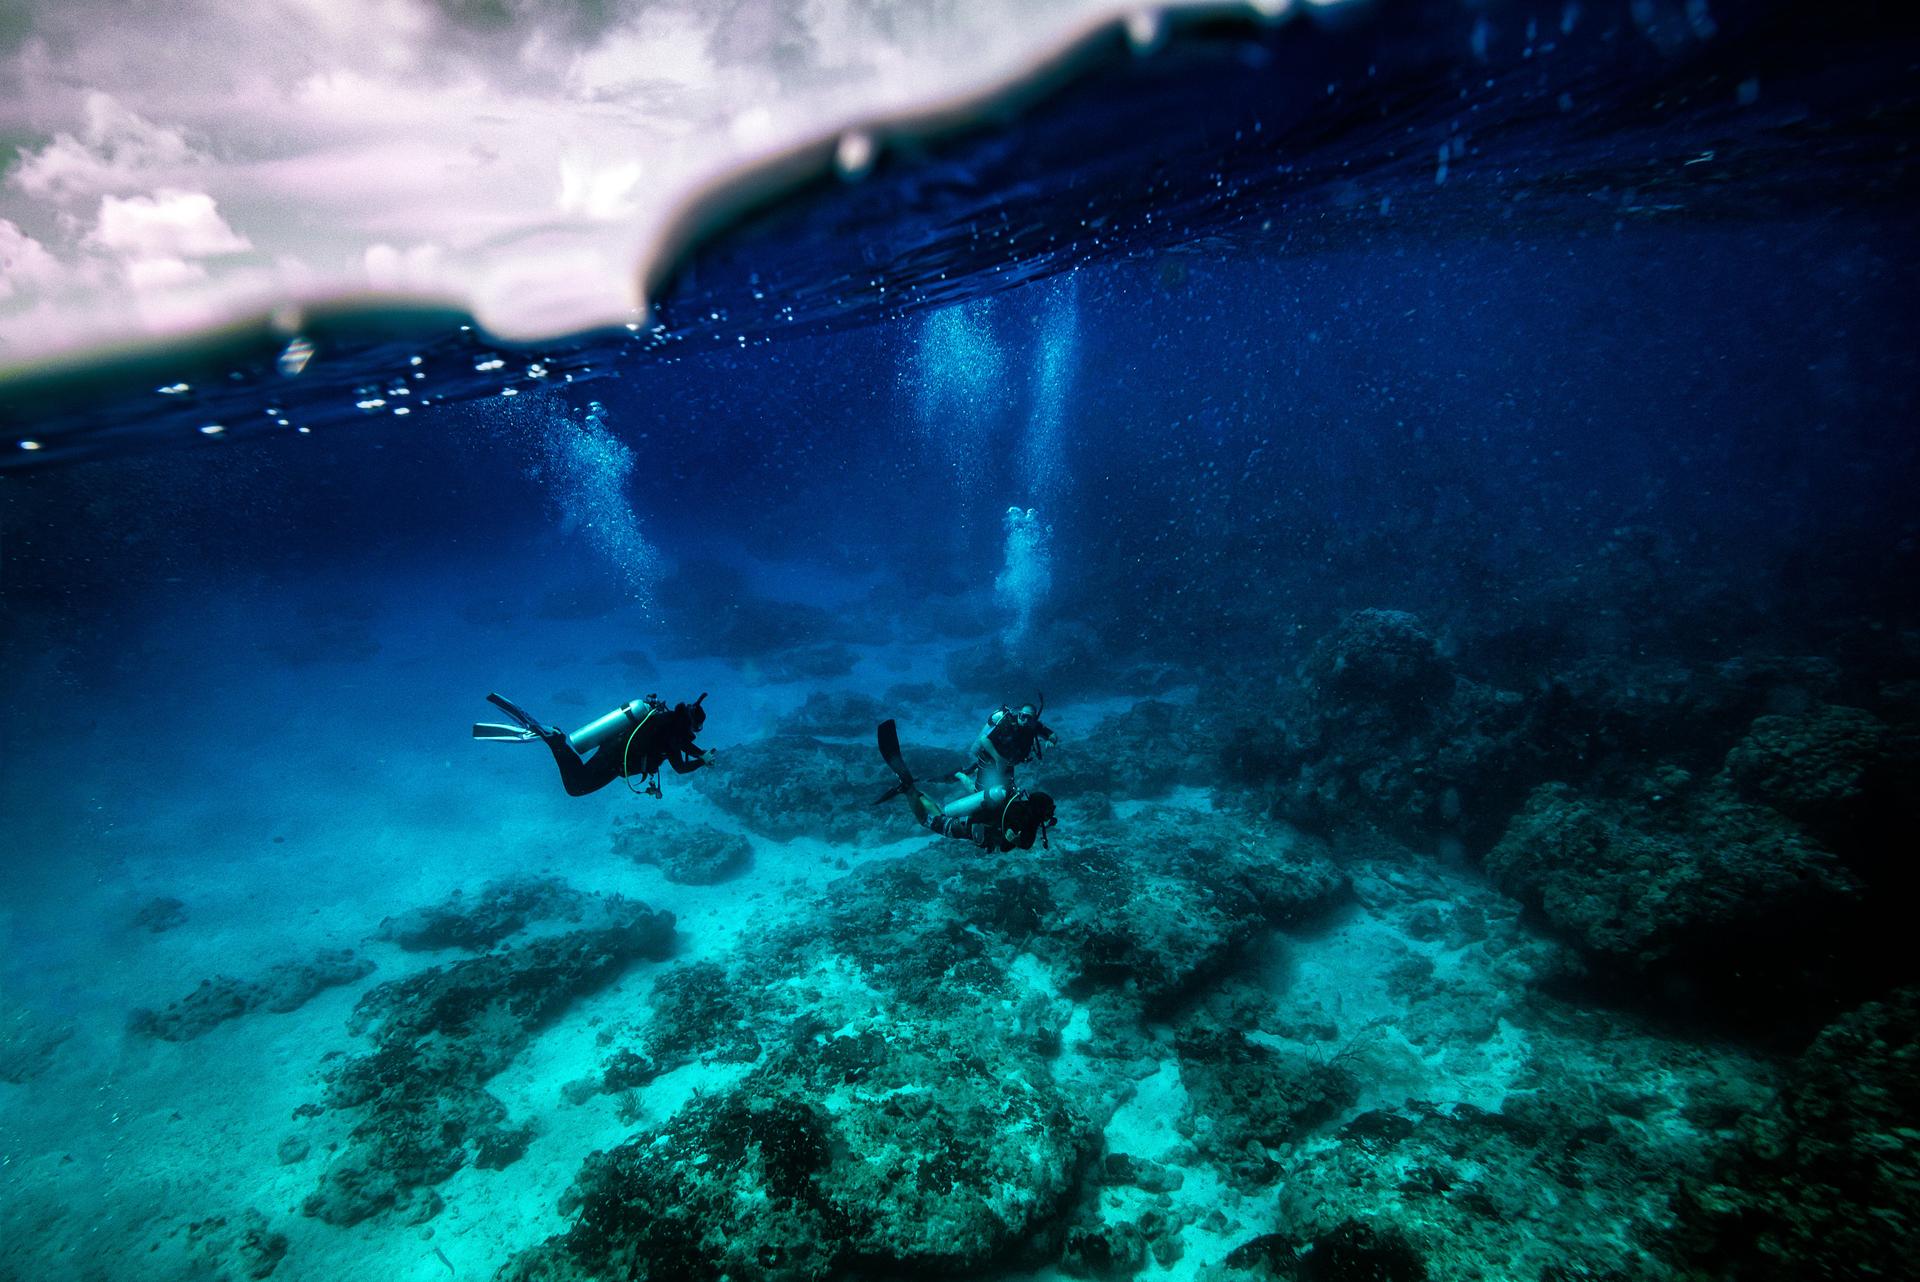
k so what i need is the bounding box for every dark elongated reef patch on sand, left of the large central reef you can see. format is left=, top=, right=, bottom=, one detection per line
left=303, top=896, right=674, bottom=1224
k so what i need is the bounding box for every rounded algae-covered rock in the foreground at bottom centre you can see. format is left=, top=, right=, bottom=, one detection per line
left=501, top=1027, right=1092, bottom=1282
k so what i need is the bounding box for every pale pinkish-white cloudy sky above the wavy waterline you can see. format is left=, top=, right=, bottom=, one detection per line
left=0, top=0, right=1244, bottom=367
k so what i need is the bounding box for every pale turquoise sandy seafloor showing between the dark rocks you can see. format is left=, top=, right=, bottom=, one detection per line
left=0, top=545, right=1866, bottom=1282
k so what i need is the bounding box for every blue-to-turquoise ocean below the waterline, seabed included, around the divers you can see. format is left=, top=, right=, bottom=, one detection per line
left=0, top=2, right=1920, bottom=1280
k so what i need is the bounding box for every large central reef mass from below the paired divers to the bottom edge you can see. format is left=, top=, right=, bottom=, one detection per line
left=503, top=812, right=1346, bottom=1282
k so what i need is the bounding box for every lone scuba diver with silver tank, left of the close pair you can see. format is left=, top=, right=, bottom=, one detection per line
left=474, top=691, right=714, bottom=796
